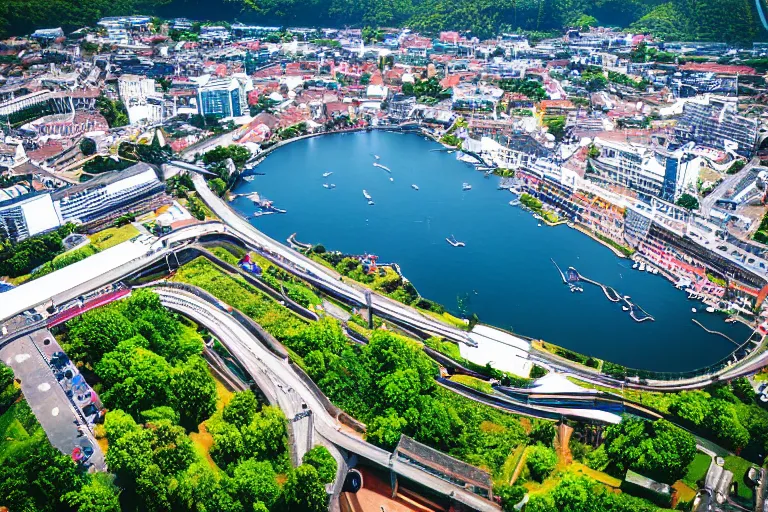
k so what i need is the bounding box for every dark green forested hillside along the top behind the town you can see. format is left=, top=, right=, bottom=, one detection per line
left=0, top=0, right=768, bottom=43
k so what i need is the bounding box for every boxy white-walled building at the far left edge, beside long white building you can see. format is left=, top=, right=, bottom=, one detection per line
left=0, top=194, right=61, bottom=243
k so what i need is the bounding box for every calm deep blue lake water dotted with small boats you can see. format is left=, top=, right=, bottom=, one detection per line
left=232, top=132, right=750, bottom=371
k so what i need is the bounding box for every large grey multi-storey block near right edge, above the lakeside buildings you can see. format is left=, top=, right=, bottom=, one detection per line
left=675, top=100, right=758, bottom=158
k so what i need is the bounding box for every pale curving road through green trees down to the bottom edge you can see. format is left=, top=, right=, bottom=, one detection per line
left=155, top=288, right=499, bottom=512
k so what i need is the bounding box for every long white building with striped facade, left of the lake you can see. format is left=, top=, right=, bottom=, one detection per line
left=51, top=163, right=169, bottom=229
